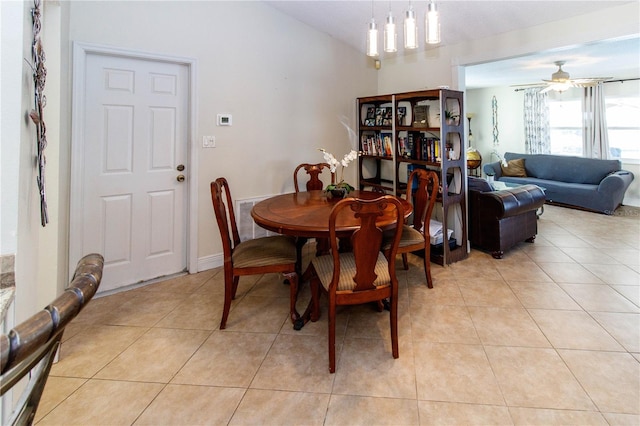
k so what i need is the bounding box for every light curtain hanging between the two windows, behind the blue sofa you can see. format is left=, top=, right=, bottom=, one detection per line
left=582, top=82, right=610, bottom=159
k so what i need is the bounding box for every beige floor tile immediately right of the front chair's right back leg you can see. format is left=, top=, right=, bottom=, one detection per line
left=411, top=305, right=480, bottom=344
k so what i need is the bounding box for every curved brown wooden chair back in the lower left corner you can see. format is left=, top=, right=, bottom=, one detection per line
left=0, top=254, right=104, bottom=425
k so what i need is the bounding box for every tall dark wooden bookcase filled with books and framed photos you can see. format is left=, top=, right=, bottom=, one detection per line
left=357, top=89, right=468, bottom=265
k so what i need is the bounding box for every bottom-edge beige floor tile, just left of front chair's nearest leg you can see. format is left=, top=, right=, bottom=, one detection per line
left=229, top=389, right=329, bottom=426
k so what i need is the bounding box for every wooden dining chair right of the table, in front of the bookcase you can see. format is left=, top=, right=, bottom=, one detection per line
left=382, top=169, right=438, bottom=288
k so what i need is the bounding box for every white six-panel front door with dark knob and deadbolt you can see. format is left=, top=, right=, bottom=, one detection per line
left=70, top=53, right=190, bottom=292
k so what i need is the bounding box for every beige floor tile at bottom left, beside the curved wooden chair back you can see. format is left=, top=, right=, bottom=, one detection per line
left=38, top=380, right=164, bottom=426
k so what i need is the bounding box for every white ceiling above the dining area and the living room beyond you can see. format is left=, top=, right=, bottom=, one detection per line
left=264, top=0, right=640, bottom=88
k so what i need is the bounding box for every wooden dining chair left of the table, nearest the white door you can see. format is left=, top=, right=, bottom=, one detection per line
left=211, top=177, right=299, bottom=330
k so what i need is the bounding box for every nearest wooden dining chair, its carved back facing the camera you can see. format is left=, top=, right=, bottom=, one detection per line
left=307, top=195, right=404, bottom=373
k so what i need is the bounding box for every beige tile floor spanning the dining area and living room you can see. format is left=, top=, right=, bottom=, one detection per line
left=36, top=206, right=640, bottom=425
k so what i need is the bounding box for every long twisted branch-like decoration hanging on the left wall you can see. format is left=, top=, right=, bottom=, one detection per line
left=29, top=0, right=49, bottom=226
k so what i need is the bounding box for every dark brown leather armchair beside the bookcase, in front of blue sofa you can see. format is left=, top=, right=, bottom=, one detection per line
left=469, top=177, right=545, bottom=259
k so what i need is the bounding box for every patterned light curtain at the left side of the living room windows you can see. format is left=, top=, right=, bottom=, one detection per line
left=524, top=88, right=551, bottom=154
